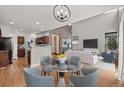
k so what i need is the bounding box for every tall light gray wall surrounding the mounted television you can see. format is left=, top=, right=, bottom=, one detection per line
left=72, top=10, right=118, bottom=52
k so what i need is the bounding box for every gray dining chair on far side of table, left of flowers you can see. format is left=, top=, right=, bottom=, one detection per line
left=40, top=56, right=57, bottom=75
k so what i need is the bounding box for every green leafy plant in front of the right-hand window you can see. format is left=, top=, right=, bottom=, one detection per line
left=107, top=37, right=118, bottom=51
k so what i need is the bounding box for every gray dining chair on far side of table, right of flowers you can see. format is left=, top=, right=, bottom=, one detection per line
left=66, top=56, right=80, bottom=75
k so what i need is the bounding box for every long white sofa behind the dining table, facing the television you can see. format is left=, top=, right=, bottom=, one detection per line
left=65, top=50, right=98, bottom=64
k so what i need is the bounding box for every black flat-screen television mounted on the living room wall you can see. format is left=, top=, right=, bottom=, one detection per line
left=83, top=39, right=98, bottom=48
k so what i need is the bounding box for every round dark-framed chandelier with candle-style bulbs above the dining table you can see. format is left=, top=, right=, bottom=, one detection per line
left=53, top=5, right=71, bottom=22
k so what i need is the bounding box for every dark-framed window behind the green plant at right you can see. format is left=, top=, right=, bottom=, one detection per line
left=105, top=32, right=118, bottom=52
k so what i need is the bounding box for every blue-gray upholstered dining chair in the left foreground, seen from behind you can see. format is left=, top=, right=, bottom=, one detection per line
left=24, top=66, right=54, bottom=87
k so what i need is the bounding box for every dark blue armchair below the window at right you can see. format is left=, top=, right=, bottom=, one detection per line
left=101, top=52, right=115, bottom=63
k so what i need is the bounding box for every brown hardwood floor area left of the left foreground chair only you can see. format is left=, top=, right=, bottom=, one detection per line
left=0, top=58, right=25, bottom=87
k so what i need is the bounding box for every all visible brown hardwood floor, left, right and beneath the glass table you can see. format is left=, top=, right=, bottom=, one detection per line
left=0, top=58, right=124, bottom=87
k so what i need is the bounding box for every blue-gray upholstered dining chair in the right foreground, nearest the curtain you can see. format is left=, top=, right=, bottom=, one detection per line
left=70, top=68, right=99, bottom=87
